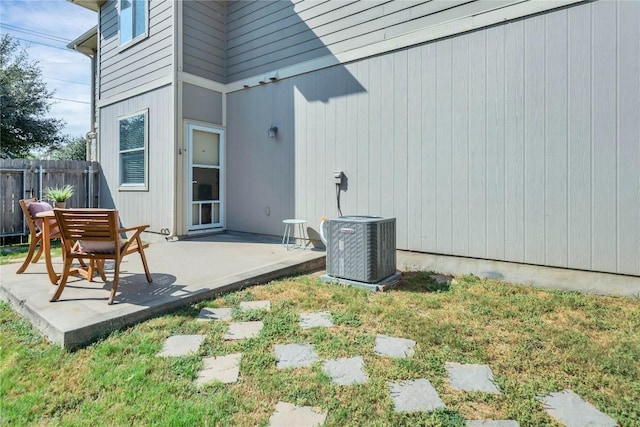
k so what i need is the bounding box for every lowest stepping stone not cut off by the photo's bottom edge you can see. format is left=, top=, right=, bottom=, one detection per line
left=389, top=378, right=446, bottom=412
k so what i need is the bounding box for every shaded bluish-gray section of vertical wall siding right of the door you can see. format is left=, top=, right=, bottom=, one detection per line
left=225, top=79, right=296, bottom=235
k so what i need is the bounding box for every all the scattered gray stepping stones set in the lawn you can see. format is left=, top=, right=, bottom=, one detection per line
left=152, top=301, right=618, bottom=427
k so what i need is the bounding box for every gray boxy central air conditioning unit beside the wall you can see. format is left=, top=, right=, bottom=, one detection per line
left=327, top=216, right=396, bottom=283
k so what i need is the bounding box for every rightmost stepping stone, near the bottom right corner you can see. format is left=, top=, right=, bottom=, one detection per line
left=540, top=390, right=618, bottom=427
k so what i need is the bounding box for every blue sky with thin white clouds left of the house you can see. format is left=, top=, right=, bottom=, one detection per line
left=0, top=0, right=98, bottom=137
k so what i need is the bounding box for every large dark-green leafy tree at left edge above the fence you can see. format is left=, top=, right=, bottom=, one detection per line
left=0, top=35, right=64, bottom=158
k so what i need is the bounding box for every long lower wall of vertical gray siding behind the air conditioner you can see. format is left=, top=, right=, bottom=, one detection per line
left=227, top=1, right=640, bottom=275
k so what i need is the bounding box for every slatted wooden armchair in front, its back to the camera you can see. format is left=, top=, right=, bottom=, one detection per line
left=51, top=209, right=153, bottom=304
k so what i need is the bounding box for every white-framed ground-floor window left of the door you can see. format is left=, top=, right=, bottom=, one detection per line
left=118, top=110, right=149, bottom=190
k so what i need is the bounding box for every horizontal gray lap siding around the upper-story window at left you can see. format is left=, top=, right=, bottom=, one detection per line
left=100, top=0, right=174, bottom=99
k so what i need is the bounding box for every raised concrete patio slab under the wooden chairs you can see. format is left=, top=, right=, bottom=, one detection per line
left=0, top=233, right=325, bottom=349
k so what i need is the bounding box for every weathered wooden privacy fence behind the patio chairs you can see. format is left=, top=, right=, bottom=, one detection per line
left=0, top=159, right=100, bottom=241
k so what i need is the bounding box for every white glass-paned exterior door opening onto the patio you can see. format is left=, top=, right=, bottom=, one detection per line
left=187, top=124, right=225, bottom=231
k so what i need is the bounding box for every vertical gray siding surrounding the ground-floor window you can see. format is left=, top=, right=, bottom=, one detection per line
left=100, top=86, right=176, bottom=233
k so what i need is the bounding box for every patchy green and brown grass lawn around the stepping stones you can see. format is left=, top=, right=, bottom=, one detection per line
left=0, top=273, right=640, bottom=427
